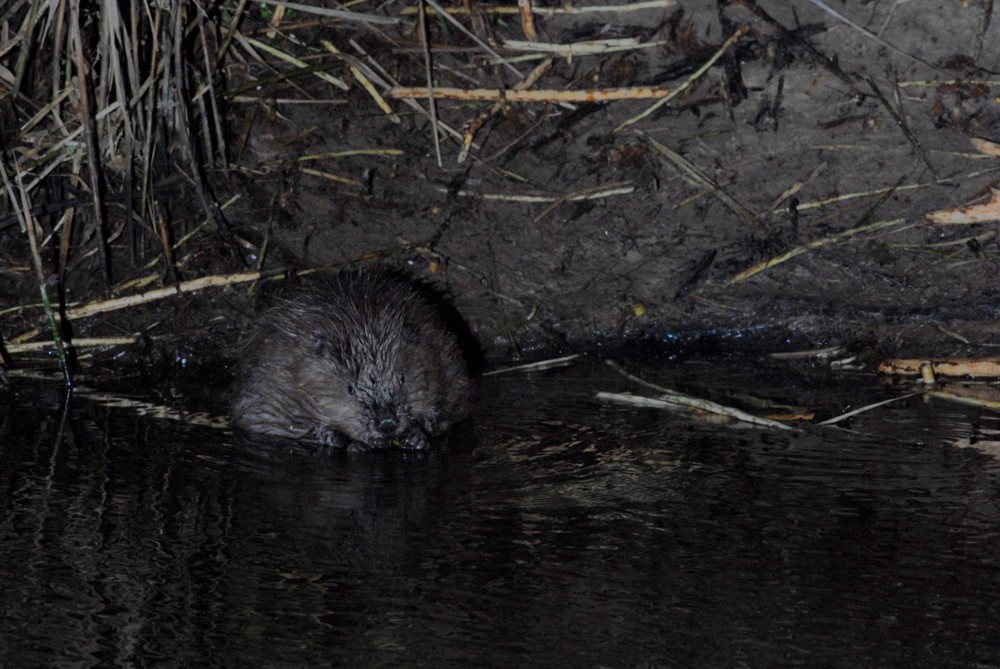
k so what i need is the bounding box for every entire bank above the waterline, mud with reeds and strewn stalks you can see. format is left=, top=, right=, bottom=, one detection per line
left=0, top=0, right=1000, bottom=370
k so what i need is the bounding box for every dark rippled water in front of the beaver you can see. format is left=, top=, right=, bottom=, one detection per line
left=0, top=362, right=1000, bottom=667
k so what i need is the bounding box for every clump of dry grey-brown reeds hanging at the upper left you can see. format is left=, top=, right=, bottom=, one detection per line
left=0, top=0, right=245, bottom=380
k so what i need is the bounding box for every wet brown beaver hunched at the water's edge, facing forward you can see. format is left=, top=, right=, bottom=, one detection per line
left=232, top=268, right=475, bottom=450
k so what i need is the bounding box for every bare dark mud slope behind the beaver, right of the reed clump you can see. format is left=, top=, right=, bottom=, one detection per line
left=221, top=2, right=998, bottom=355
